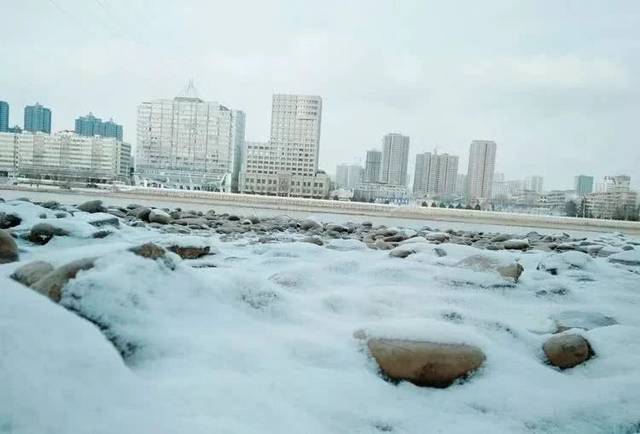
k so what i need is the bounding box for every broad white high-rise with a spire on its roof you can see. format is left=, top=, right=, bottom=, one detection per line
left=136, top=96, right=245, bottom=191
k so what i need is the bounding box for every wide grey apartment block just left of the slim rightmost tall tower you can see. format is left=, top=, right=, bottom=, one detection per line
left=413, top=152, right=458, bottom=196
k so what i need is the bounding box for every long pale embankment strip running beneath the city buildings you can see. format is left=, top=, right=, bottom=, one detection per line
left=0, top=186, right=640, bottom=235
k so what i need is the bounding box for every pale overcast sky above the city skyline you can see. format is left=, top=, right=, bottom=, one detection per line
left=0, top=0, right=640, bottom=189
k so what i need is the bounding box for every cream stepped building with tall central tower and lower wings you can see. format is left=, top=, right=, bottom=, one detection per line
left=239, top=94, right=330, bottom=198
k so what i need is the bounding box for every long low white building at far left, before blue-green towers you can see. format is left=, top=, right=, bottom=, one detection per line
left=0, top=131, right=131, bottom=183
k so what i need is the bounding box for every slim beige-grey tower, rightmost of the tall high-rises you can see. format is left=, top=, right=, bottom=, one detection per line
left=467, top=140, right=496, bottom=203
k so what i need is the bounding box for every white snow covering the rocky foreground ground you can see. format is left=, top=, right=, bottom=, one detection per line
left=0, top=201, right=640, bottom=434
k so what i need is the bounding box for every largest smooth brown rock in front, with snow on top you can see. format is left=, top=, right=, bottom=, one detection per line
left=367, top=339, right=485, bottom=388
